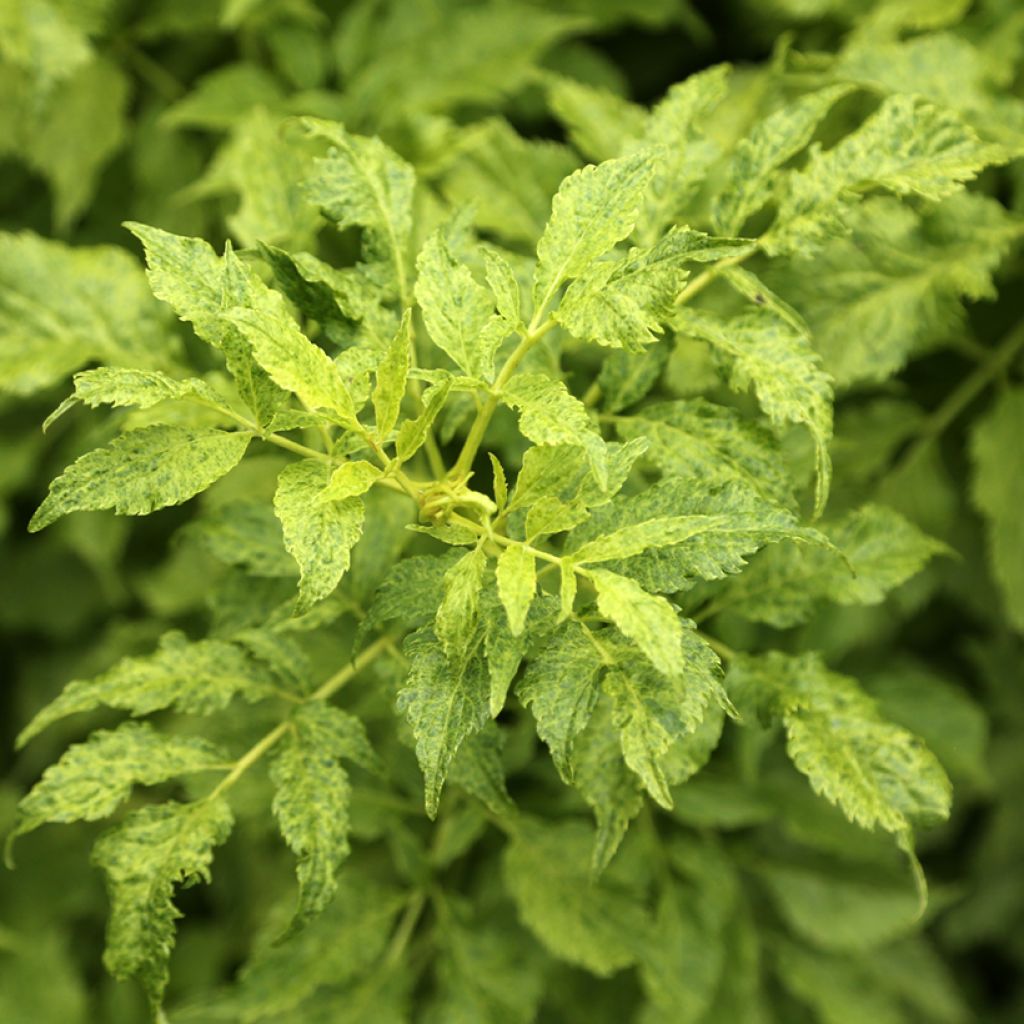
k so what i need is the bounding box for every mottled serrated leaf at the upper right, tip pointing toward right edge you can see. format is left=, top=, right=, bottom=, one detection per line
left=762, top=95, right=1007, bottom=255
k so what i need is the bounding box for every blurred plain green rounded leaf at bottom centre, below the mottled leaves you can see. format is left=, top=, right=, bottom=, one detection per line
left=504, top=822, right=650, bottom=977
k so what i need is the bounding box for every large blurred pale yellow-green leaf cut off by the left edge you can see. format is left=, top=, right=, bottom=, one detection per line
left=0, top=231, right=174, bottom=395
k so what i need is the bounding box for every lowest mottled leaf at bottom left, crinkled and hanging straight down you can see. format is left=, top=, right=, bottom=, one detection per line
left=92, top=799, right=233, bottom=1010
